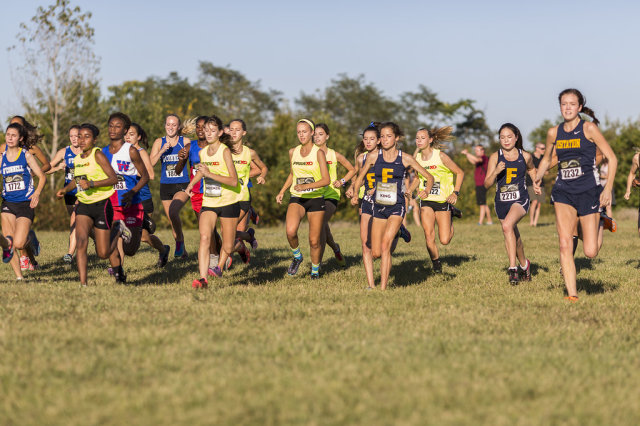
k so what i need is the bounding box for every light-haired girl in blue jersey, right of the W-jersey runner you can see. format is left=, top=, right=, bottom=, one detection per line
left=151, top=114, right=191, bottom=258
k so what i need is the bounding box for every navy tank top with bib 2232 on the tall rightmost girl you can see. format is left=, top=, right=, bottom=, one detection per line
left=554, top=120, right=600, bottom=194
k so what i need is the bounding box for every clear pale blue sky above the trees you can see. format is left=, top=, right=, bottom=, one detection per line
left=0, top=0, right=640, bottom=148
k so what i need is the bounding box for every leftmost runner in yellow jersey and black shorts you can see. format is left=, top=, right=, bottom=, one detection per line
left=56, top=123, right=122, bottom=286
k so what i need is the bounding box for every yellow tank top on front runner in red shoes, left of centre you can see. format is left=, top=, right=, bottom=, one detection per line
left=200, top=143, right=240, bottom=207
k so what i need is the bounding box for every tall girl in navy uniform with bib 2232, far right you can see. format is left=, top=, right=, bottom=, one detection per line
left=536, top=89, right=618, bottom=302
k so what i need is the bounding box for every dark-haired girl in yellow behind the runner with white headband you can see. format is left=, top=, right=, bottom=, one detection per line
left=313, top=123, right=356, bottom=267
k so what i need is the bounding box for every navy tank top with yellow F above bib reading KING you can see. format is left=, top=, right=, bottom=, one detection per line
left=373, top=150, right=405, bottom=206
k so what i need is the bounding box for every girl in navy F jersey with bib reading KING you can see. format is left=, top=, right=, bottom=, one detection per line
left=351, top=122, right=433, bottom=290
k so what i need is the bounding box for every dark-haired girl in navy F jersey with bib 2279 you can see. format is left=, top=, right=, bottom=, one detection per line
left=484, top=123, right=541, bottom=285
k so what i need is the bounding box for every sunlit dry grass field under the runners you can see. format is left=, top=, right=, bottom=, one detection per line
left=0, top=217, right=640, bottom=425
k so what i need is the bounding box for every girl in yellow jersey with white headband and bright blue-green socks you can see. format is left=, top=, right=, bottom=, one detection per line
left=276, top=118, right=330, bottom=279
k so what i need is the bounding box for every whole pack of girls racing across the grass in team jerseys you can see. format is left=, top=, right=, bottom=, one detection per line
left=0, top=89, right=640, bottom=301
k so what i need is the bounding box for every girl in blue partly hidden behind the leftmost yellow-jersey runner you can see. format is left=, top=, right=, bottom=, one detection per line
left=46, top=124, right=82, bottom=264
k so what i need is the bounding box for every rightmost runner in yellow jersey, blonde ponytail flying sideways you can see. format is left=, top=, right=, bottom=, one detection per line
left=409, top=126, right=464, bottom=272
